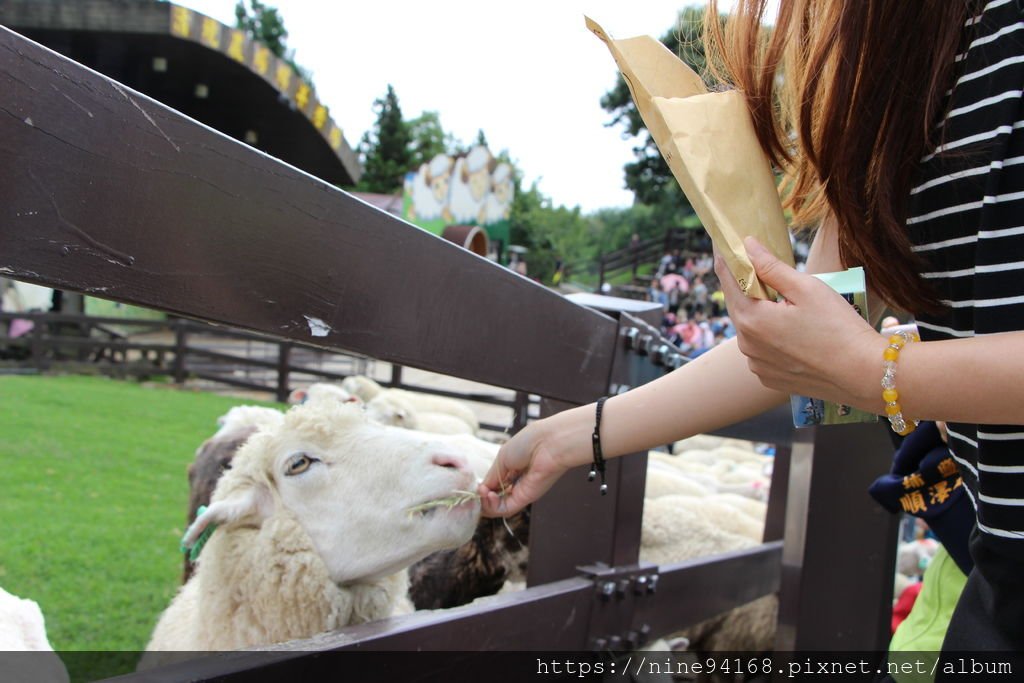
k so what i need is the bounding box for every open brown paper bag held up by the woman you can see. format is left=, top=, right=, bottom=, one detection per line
left=586, top=17, right=794, bottom=299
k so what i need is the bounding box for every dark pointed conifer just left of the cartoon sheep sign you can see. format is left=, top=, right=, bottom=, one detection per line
left=356, top=84, right=411, bottom=195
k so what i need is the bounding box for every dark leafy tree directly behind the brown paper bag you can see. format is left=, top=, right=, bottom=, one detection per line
left=601, top=7, right=707, bottom=216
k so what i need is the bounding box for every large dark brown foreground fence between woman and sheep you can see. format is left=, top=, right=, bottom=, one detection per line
left=0, top=18, right=896, bottom=680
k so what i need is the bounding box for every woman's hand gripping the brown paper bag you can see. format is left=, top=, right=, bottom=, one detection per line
left=715, top=238, right=887, bottom=412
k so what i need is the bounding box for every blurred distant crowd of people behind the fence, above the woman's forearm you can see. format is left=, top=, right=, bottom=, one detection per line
left=648, top=249, right=736, bottom=358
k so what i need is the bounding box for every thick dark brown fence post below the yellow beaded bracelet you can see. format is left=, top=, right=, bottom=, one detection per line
left=772, top=424, right=897, bottom=651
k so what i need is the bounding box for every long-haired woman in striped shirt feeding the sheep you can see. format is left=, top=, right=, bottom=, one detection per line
left=479, top=0, right=1024, bottom=663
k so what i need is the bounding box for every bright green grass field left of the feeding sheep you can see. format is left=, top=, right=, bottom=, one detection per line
left=0, top=376, right=280, bottom=663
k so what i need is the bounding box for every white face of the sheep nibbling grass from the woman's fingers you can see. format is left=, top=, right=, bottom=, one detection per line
left=192, top=400, right=479, bottom=584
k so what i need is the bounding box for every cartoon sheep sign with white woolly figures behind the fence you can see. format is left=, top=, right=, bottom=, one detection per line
left=402, top=145, right=514, bottom=259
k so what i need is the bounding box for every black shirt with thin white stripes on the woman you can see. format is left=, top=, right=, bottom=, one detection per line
left=907, top=0, right=1024, bottom=560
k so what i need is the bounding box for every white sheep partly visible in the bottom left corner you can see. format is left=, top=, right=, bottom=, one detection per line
left=0, top=588, right=68, bottom=683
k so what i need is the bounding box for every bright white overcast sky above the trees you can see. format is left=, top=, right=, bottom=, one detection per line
left=174, top=0, right=708, bottom=213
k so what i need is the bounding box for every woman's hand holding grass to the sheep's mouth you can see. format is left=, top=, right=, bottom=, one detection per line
left=477, top=418, right=577, bottom=517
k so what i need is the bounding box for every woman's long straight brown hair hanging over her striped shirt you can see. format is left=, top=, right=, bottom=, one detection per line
left=705, top=0, right=970, bottom=311
